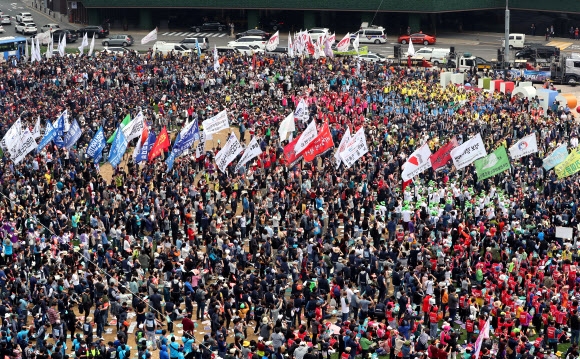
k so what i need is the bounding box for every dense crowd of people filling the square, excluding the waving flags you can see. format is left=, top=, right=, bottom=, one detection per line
left=0, top=41, right=580, bottom=359
